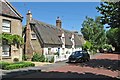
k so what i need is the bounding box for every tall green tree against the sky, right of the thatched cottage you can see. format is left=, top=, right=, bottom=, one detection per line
left=81, top=17, right=106, bottom=52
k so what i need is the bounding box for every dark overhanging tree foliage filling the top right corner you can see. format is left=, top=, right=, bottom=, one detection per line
left=96, top=1, right=120, bottom=28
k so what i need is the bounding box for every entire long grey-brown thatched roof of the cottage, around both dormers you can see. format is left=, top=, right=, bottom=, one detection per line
left=31, top=19, right=82, bottom=47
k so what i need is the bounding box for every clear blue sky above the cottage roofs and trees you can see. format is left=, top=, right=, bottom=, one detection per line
left=11, top=2, right=100, bottom=32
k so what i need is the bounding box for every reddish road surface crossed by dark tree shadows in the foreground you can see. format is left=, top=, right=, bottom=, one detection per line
left=2, top=54, right=120, bottom=78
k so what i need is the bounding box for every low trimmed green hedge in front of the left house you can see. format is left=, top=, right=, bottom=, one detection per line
left=2, top=62, right=35, bottom=70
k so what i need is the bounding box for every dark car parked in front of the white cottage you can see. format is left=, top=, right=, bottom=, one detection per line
left=68, top=51, right=90, bottom=62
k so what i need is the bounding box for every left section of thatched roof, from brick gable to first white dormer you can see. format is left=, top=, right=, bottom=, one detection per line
left=32, top=20, right=62, bottom=45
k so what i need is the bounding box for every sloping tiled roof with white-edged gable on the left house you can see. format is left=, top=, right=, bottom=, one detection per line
left=0, top=1, right=22, bottom=20
